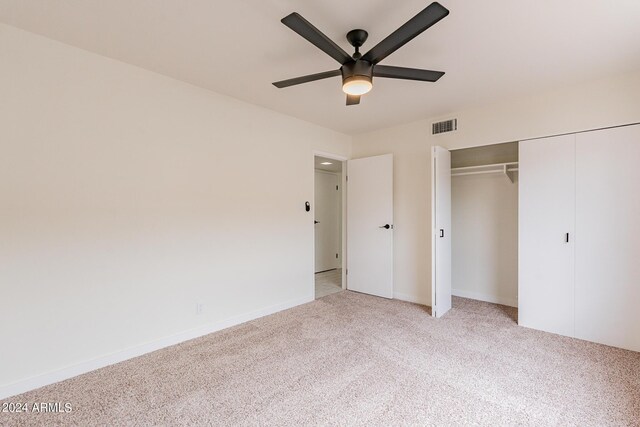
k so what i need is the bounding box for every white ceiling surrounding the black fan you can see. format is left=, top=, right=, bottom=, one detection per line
left=0, top=0, right=640, bottom=134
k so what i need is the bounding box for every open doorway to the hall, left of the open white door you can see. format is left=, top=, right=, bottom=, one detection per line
left=313, top=155, right=344, bottom=299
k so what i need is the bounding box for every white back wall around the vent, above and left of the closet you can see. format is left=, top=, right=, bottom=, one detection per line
left=352, top=73, right=640, bottom=305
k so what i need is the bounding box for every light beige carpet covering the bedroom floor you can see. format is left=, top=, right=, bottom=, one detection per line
left=0, top=292, right=640, bottom=426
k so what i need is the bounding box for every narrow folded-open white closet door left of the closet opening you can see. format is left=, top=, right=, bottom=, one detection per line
left=431, top=147, right=451, bottom=317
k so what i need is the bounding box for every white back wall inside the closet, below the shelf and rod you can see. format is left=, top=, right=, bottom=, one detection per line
left=451, top=173, right=518, bottom=307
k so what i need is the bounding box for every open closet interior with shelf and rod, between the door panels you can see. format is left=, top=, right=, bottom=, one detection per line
left=451, top=142, right=519, bottom=308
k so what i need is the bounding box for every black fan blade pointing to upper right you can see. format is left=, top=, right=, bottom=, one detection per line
left=362, top=2, right=449, bottom=64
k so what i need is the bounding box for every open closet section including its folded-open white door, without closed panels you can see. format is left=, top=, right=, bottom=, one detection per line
left=431, top=142, right=518, bottom=317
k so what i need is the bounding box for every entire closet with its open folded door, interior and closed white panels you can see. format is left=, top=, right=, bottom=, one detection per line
left=431, top=124, right=640, bottom=351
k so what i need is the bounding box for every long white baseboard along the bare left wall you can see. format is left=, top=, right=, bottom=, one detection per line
left=0, top=296, right=314, bottom=400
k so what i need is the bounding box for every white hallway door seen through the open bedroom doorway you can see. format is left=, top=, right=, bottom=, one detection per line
left=313, top=171, right=340, bottom=273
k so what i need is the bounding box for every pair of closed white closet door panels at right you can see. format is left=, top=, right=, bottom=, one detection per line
left=518, top=125, right=640, bottom=351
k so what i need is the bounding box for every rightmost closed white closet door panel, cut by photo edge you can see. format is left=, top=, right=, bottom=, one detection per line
left=575, top=126, right=640, bottom=351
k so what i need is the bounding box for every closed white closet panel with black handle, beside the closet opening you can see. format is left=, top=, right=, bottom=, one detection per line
left=518, top=135, right=575, bottom=336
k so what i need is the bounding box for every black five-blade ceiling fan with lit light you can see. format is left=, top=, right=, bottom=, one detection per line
left=273, top=2, right=449, bottom=105
